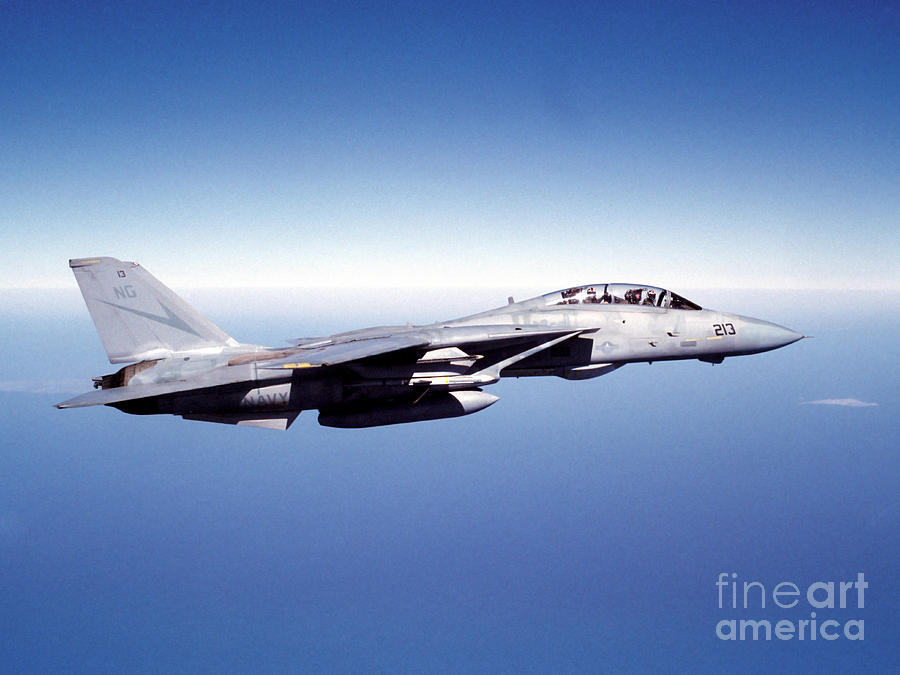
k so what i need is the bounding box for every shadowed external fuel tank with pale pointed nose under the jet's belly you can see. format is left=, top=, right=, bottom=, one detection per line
left=319, top=389, right=499, bottom=429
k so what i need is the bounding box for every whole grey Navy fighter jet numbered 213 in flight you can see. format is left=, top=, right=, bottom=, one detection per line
left=57, top=257, right=804, bottom=429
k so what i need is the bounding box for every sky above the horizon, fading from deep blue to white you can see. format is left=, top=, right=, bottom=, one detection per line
left=0, top=0, right=900, bottom=289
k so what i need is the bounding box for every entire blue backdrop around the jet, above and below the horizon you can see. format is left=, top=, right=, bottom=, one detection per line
left=0, top=2, right=900, bottom=673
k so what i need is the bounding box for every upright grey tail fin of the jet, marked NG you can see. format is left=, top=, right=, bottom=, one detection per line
left=69, top=258, right=237, bottom=363
